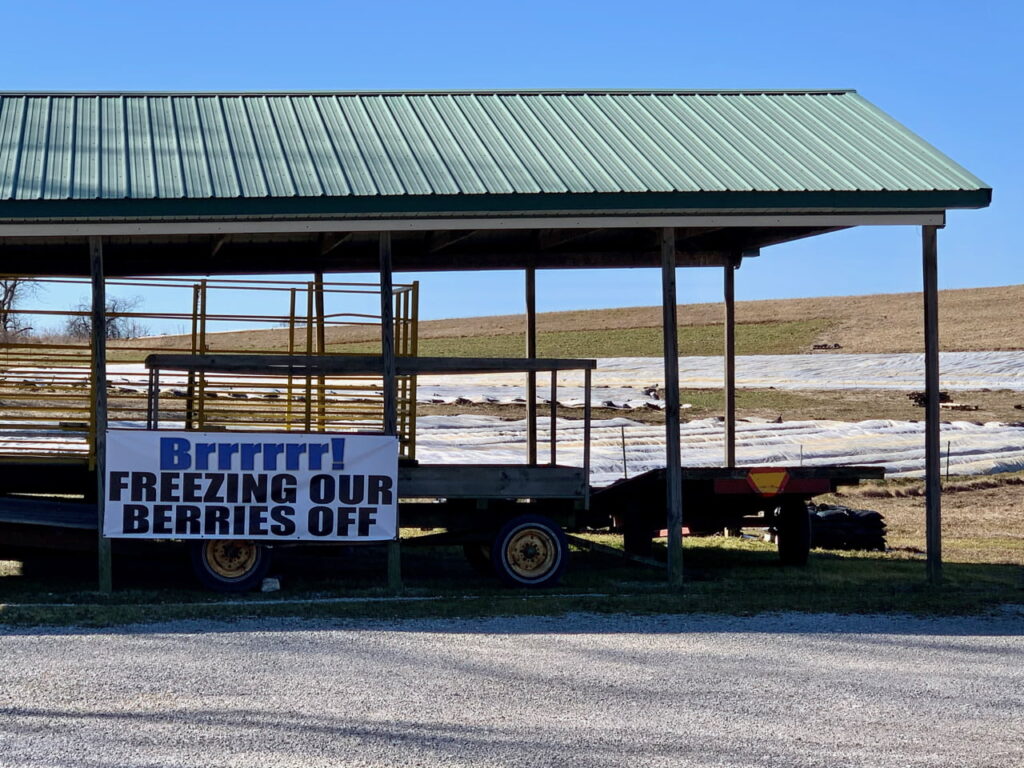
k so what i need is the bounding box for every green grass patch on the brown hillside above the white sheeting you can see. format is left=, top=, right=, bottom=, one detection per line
left=330, top=319, right=828, bottom=357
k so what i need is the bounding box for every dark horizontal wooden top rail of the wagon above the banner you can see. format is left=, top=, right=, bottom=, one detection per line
left=145, top=354, right=597, bottom=376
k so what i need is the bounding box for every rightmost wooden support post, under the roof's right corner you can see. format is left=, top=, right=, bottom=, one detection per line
left=922, top=226, right=942, bottom=584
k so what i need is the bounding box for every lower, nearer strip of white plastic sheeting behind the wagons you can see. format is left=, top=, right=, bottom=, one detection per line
left=417, top=416, right=1024, bottom=485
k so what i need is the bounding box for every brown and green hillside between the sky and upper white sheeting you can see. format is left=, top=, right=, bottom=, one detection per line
left=138, top=285, right=1024, bottom=356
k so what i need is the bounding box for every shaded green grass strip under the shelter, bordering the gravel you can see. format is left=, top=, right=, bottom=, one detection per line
left=0, top=537, right=1024, bottom=626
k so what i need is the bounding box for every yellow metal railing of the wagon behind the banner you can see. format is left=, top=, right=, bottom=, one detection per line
left=0, top=276, right=419, bottom=459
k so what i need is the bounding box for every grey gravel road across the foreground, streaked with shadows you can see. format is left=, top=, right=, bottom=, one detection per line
left=0, top=611, right=1024, bottom=768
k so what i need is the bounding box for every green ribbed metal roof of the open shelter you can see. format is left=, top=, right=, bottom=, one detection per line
left=0, top=90, right=991, bottom=218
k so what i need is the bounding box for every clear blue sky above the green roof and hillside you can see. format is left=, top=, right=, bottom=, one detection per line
left=0, top=0, right=1024, bottom=325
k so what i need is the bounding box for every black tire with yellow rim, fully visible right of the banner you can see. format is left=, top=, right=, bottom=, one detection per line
left=490, top=515, right=569, bottom=587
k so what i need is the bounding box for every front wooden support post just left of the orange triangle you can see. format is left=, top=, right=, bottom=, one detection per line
left=662, top=227, right=683, bottom=587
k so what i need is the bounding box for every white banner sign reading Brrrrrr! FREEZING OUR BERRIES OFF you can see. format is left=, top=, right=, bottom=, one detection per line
left=103, top=430, right=398, bottom=542
